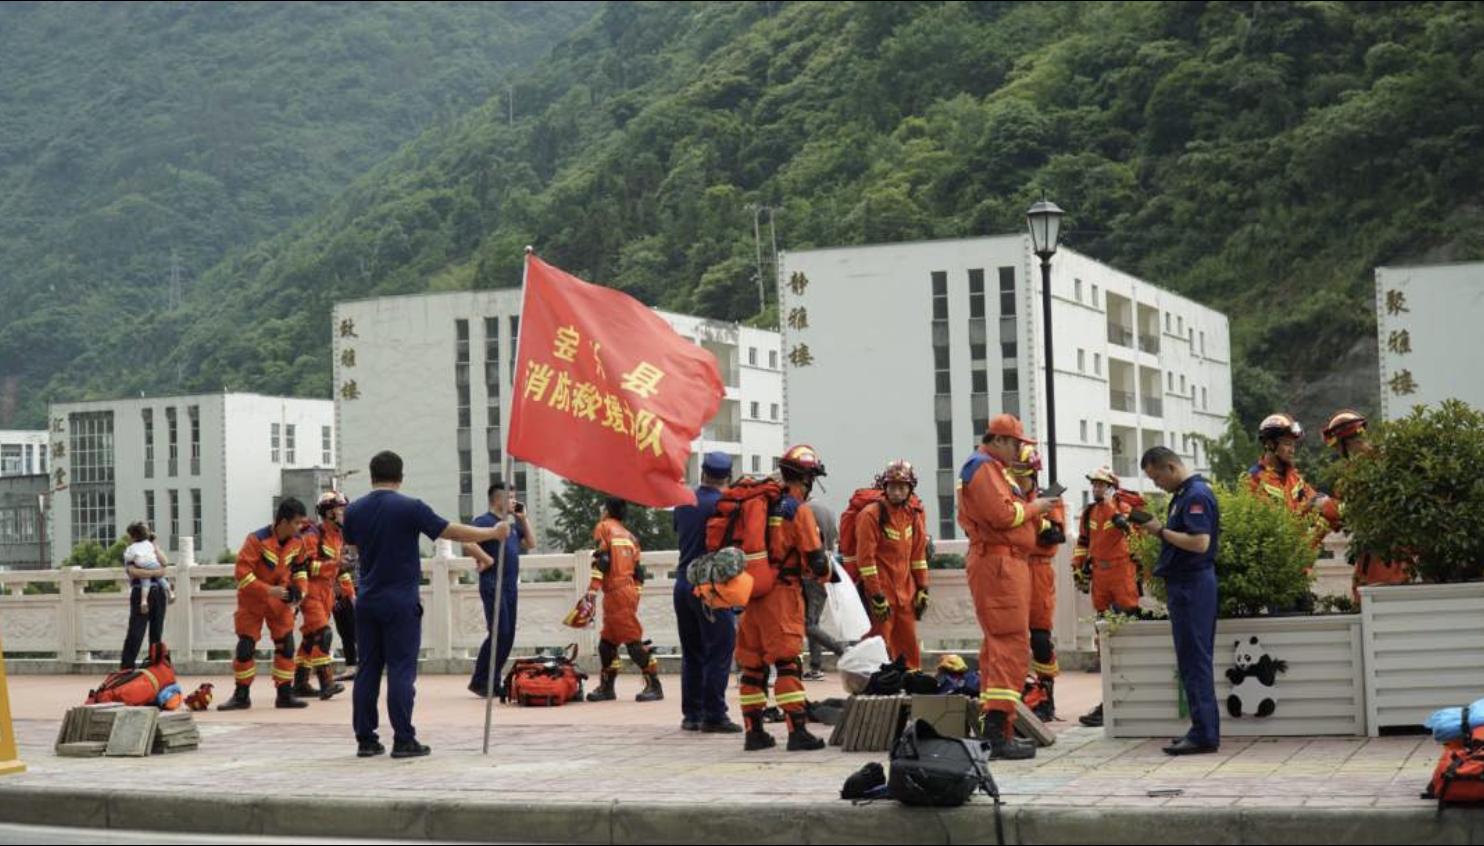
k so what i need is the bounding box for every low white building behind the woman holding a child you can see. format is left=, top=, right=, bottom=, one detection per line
left=50, top=393, right=335, bottom=565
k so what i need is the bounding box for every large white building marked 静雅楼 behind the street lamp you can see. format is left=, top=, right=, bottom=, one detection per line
left=779, top=235, right=1232, bottom=539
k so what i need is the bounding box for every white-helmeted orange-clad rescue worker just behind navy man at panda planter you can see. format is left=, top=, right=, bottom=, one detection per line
left=1071, top=468, right=1140, bottom=729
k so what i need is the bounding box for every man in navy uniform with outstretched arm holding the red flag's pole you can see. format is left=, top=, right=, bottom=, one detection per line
left=344, top=451, right=510, bottom=758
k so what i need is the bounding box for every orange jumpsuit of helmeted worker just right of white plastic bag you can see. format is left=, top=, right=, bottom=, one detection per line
left=855, top=500, right=928, bottom=669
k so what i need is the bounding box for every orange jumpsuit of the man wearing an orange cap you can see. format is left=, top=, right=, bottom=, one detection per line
left=959, top=447, right=1042, bottom=724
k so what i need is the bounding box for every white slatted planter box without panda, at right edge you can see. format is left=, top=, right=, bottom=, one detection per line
left=1361, top=582, right=1484, bottom=736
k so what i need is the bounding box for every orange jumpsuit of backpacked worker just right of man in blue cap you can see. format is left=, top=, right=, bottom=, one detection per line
left=736, top=484, right=828, bottom=730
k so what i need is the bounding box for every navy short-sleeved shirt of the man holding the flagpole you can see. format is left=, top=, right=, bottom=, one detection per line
left=344, top=488, right=448, bottom=603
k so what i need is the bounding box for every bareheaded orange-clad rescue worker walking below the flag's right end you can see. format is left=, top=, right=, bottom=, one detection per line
left=588, top=497, right=665, bottom=702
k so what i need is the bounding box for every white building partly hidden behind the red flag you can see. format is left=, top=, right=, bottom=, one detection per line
left=334, top=289, right=784, bottom=545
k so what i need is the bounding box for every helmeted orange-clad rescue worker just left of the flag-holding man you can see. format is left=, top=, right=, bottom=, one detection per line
left=294, top=491, right=356, bottom=699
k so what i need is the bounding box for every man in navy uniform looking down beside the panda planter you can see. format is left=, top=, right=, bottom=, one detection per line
left=1140, top=447, right=1221, bottom=755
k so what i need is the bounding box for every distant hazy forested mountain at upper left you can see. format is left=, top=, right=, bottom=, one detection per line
left=0, top=1, right=594, bottom=427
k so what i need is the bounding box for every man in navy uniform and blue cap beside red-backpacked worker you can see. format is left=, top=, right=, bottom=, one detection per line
left=675, top=453, right=742, bottom=735
